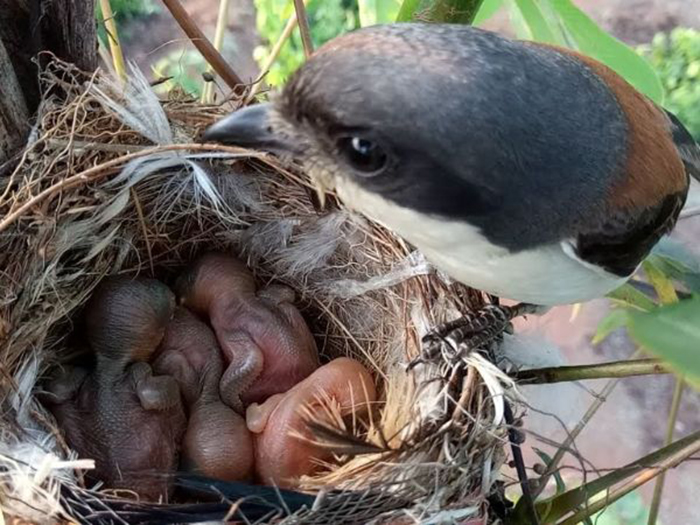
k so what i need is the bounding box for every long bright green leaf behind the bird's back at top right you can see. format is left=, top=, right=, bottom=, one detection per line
left=542, top=0, right=663, bottom=104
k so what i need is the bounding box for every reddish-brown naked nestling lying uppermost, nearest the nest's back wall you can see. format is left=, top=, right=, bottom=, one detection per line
left=178, top=253, right=318, bottom=414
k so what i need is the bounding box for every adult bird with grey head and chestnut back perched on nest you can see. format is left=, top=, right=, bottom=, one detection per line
left=204, top=23, right=700, bottom=360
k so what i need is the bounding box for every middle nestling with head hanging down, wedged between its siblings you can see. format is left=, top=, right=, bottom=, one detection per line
left=153, top=307, right=254, bottom=481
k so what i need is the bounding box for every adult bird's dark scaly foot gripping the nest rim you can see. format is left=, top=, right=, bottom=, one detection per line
left=409, top=303, right=541, bottom=369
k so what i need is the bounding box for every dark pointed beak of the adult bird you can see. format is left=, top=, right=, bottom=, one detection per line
left=202, top=104, right=293, bottom=152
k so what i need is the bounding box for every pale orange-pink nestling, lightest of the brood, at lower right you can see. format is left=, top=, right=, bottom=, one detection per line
left=246, top=357, right=377, bottom=488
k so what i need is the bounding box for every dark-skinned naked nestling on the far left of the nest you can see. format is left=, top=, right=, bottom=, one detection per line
left=46, top=278, right=185, bottom=501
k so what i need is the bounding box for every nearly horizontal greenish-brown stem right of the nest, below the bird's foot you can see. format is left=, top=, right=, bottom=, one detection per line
left=513, top=359, right=671, bottom=385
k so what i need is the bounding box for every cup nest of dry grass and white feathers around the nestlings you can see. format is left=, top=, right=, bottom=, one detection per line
left=0, top=61, right=513, bottom=523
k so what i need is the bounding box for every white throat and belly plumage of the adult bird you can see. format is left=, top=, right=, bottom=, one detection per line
left=335, top=178, right=626, bottom=306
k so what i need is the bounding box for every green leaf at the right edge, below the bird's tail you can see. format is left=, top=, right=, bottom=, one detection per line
left=627, top=296, right=700, bottom=385
